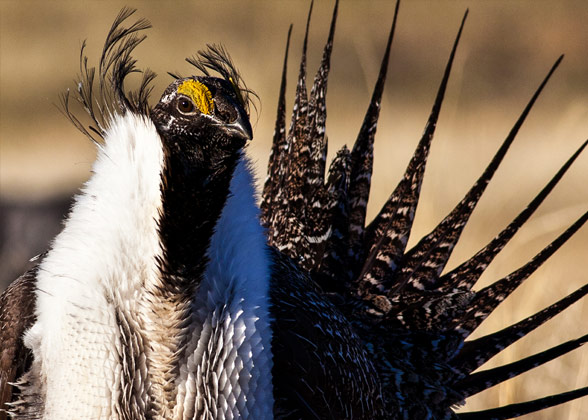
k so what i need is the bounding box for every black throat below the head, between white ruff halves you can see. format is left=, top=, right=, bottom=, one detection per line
left=159, top=141, right=240, bottom=296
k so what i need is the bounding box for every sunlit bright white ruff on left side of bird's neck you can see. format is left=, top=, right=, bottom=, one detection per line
left=26, top=113, right=163, bottom=419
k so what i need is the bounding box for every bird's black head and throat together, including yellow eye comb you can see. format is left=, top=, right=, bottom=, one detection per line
left=151, top=77, right=251, bottom=290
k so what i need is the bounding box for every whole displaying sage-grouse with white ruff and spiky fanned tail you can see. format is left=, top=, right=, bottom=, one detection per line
left=0, top=4, right=588, bottom=420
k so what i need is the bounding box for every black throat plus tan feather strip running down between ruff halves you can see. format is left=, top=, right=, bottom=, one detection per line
left=142, top=138, right=245, bottom=419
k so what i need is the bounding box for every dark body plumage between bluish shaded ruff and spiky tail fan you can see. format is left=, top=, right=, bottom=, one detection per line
left=270, top=250, right=387, bottom=420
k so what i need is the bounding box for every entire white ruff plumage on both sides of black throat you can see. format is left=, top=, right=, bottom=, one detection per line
left=20, top=113, right=274, bottom=420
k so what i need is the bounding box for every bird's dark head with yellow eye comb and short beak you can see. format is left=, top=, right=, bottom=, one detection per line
left=151, top=76, right=253, bottom=170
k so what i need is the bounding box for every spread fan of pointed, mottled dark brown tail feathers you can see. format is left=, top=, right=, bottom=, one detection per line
left=262, top=0, right=588, bottom=419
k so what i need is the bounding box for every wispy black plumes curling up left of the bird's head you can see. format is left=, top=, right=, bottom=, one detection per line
left=61, top=7, right=156, bottom=143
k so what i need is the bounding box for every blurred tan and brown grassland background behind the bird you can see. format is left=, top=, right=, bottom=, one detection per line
left=0, top=0, right=588, bottom=419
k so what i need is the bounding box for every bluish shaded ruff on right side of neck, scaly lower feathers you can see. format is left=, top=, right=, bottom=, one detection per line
left=176, top=155, right=274, bottom=420
